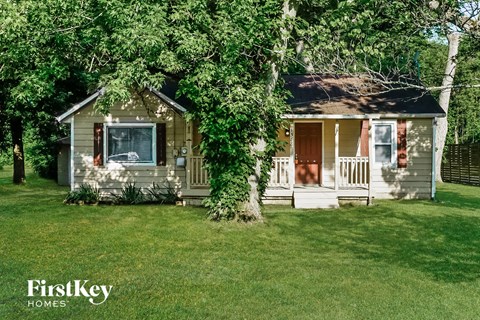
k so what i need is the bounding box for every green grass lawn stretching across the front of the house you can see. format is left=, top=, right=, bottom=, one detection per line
left=0, top=169, right=480, bottom=319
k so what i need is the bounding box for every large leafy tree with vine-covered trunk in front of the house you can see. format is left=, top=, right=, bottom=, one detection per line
left=82, top=0, right=302, bottom=220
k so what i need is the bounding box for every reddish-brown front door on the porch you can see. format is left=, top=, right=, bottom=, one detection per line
left=295, top=123, right=322, bottom=185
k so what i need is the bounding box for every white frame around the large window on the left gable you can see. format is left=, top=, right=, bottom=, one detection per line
left=103, top=123, right=157, bottom=166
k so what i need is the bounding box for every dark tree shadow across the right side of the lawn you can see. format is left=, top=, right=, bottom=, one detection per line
left=270, top=196, right=480, bottom=283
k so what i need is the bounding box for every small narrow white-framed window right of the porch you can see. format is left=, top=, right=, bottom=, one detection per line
left=374, top=121, right=397, bottom=164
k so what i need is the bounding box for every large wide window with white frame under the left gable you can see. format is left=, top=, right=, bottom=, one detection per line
left=106, top=124, right=156, bottom=164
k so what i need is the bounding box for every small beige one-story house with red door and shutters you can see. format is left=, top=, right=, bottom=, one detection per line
left=57, top=75, right=445, bottom=208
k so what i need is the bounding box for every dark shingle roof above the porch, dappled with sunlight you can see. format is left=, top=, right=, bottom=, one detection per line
left=283, top=75, right=445, bottom=116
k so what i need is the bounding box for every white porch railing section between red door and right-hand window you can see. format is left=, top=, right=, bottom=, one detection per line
left=338, top=157, right=369, bottom=188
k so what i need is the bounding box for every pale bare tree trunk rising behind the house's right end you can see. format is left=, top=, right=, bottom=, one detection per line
left=435, top=32, right=460, bottom=182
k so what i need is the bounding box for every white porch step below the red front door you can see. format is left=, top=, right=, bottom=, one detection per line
left=293, top=189, right=338, bottom=209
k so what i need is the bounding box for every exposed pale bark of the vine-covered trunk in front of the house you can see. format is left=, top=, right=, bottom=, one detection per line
left=244, top=0, right=297, bottom=221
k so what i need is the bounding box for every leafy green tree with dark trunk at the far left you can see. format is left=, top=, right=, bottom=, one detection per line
left=0, top=0, right=93, bottom=183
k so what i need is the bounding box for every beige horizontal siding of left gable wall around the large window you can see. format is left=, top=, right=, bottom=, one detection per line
left=73, top=92, right=186, bottom=193
